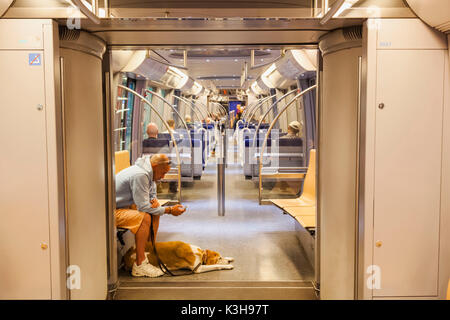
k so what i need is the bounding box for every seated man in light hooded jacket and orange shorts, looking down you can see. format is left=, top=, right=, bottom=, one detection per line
left=114, top=154, right=185, bottom=277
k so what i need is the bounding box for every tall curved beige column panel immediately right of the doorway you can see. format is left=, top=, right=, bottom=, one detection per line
left=318, top=47, right=362, bottom=299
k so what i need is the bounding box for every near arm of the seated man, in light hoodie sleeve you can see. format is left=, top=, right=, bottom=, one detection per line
left=130, top=174, right=166, bottom=216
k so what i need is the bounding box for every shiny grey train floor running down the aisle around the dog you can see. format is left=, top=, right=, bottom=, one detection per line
left=121, top=148, right=314, bottom=282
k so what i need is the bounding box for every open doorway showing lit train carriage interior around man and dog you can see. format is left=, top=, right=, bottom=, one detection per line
left=104, top=46, right=320, bottom=299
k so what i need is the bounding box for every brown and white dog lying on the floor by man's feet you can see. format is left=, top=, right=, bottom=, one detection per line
left=123, top=241, right=234, bottom=273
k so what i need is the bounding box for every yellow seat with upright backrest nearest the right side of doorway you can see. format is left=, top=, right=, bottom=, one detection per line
left=270, top=149, right=316, bottom=209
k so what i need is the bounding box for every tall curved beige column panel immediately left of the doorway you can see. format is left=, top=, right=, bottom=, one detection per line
left=60, top=48, right=107, bottom=300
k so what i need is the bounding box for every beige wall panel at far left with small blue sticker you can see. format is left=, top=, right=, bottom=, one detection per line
left=0, top=20, right=66, bottom=299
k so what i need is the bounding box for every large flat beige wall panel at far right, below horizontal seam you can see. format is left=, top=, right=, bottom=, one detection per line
left=373, top=50, right=444, bottom=296
